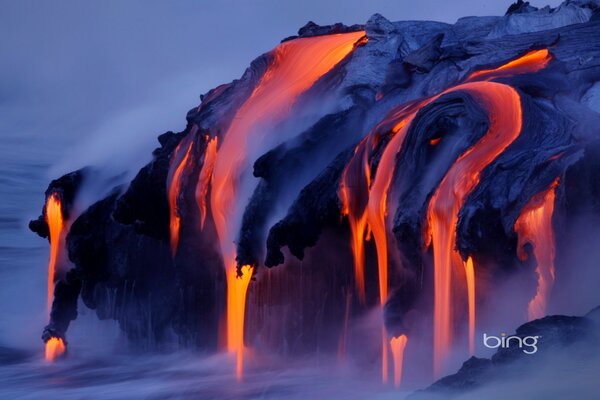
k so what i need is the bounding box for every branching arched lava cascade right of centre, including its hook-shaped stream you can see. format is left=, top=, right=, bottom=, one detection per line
left=340, top=49, right=551, bottom=382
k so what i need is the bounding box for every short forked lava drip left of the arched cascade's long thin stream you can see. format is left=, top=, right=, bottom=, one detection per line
left=339, top=137, right=371, bottom=304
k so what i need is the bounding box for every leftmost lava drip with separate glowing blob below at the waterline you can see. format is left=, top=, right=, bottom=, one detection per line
left=45, top=192, right=65, bottom=361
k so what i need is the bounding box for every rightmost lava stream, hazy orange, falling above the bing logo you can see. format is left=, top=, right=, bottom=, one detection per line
left=515, top=178, right=559, bottom=320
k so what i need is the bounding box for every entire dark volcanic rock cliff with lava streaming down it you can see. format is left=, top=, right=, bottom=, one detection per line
left=30, top=0, right=600, bottom=388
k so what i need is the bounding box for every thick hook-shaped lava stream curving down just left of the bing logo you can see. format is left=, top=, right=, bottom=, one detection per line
left=427, top=81, right=522, bottom=377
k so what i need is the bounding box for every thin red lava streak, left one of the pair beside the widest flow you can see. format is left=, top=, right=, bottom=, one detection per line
left=168, top=138, right=194, bottom=256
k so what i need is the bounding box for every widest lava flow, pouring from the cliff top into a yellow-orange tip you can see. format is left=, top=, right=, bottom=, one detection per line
left=210, top=31, right=364, bottom=377
